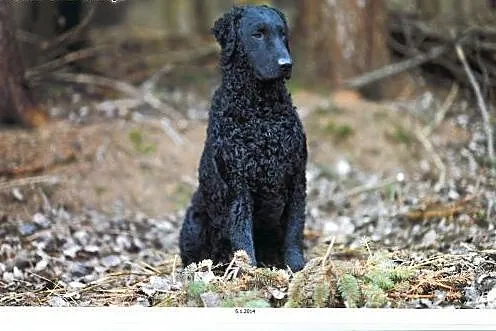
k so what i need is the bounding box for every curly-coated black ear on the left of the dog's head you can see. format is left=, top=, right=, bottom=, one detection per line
left=212, top=7, right=241, bottom=65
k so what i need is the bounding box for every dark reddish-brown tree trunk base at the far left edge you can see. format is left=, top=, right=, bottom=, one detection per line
left=0, top=0, right=46, bottom=127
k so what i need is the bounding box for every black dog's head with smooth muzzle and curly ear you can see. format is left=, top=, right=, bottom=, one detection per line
left=212, top=6, right=293, bottom=81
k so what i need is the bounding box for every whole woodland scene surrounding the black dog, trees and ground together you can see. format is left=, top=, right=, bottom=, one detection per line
left=0, top=0, right=496, bottom=308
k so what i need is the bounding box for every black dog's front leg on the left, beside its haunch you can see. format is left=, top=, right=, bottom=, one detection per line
left=228, top=191, right=257, bottom=266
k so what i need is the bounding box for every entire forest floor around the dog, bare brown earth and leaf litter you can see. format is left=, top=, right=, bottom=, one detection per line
left=0, top=38, right=496, bottom=308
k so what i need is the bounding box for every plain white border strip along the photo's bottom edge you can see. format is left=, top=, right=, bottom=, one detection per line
left=0, top=307, right=496, bottom=331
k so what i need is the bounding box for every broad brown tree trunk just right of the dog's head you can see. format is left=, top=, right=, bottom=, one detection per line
left=295, top=0, right=390, bottom=97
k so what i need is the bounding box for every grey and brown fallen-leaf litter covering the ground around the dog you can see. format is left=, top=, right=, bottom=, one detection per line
left=0, top=67, right=496, bottom=308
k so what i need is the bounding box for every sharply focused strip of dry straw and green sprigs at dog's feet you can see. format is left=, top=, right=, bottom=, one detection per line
left=0, top=247, right=480, bottom=307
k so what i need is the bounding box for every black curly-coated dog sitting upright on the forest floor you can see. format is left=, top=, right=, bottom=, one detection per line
left=180, top=6, right=307, bottom=271
